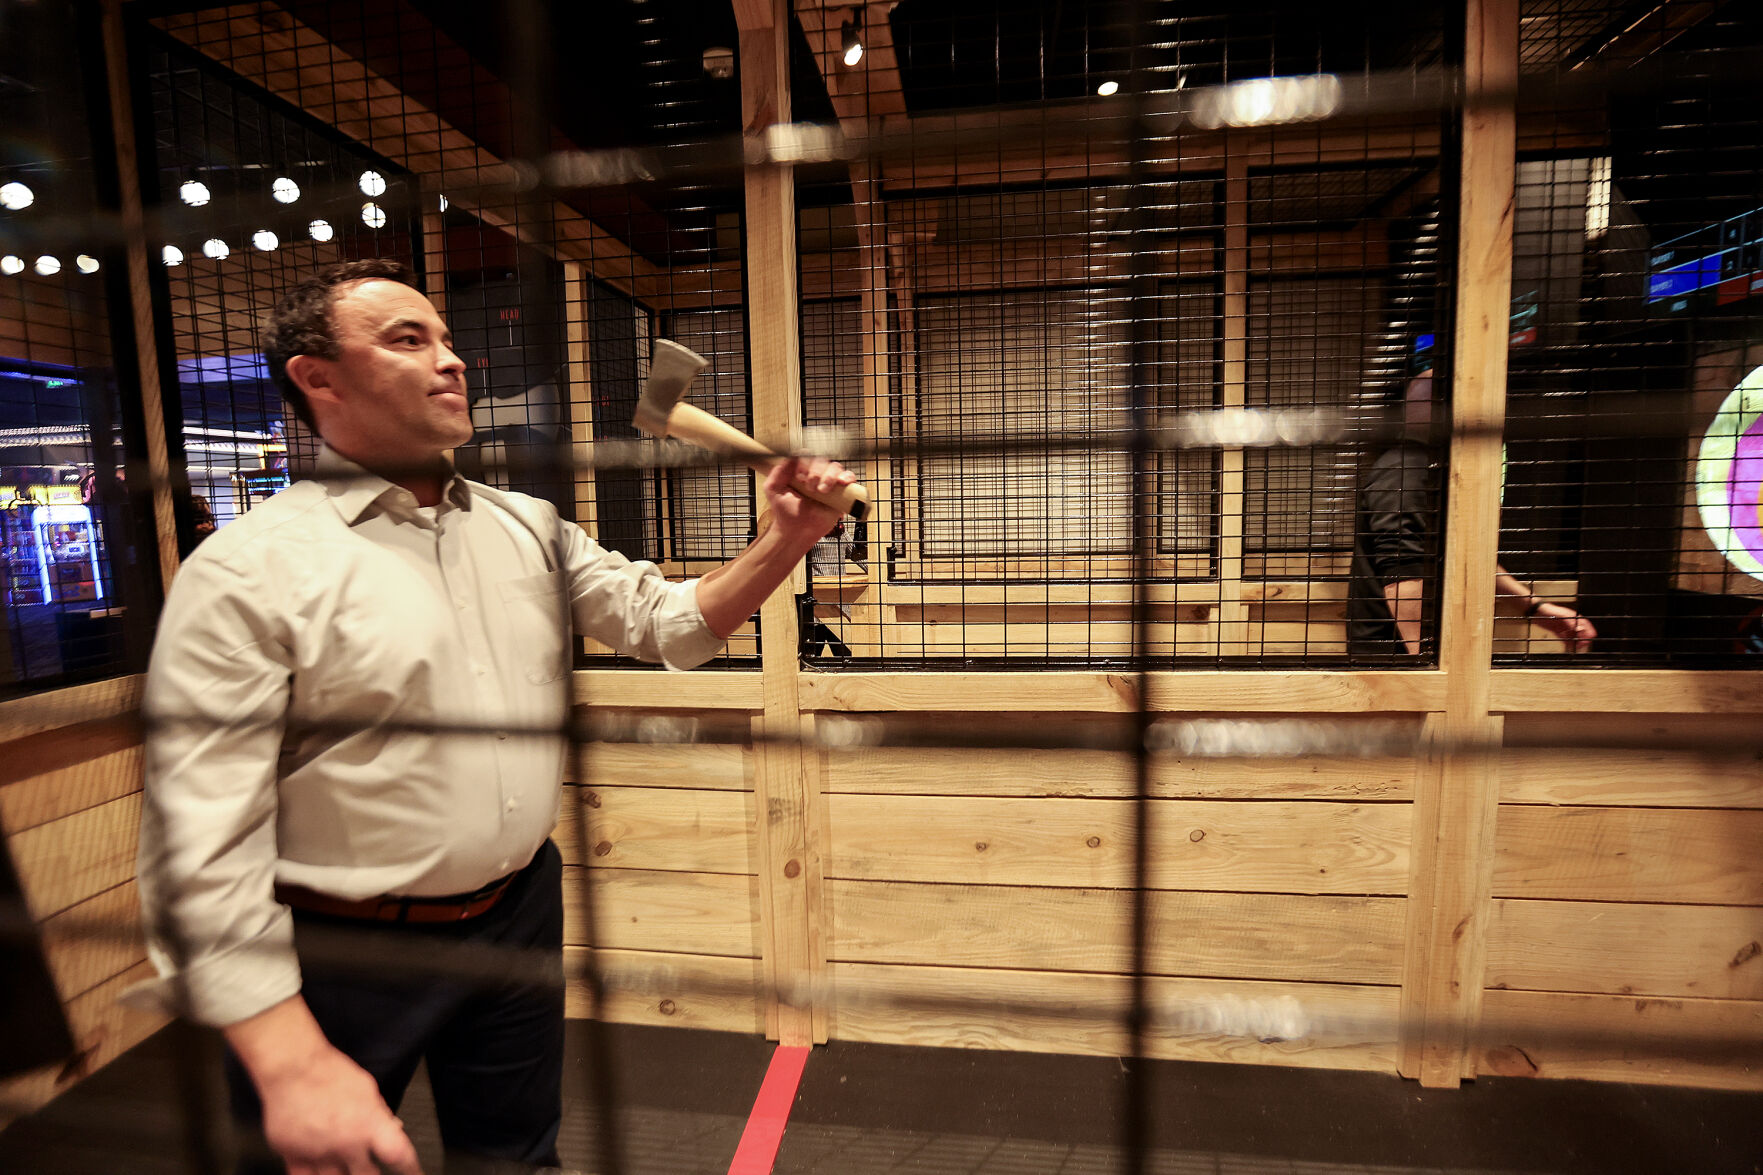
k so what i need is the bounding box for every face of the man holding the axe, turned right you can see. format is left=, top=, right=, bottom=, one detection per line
left=316, top=281, right=472, bottom=466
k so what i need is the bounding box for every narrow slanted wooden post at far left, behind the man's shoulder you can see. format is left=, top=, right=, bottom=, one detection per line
left=102, top=0, right=180, bottom=591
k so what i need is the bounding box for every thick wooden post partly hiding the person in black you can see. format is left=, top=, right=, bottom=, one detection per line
left=1402, top=0, right=1518, bottom=1087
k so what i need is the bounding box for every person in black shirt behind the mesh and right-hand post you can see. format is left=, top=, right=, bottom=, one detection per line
left=1347, top=372, right=1597, bottom=658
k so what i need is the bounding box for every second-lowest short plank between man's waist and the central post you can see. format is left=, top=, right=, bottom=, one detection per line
left=562, top=866, right=760, bottom=958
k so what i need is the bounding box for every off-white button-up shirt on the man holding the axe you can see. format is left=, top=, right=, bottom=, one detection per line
left=139, top=452, right=721, bottom=1025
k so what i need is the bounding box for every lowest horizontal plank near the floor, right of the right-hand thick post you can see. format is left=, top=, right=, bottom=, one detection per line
left=1476, top=992, right=1763, bottom=1090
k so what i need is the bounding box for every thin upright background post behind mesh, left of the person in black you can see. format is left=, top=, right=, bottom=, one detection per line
left=1213, top=141, right=1248, bottom=655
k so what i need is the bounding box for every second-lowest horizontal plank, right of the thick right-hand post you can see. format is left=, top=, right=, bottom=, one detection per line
left=1486, top=898, right=1763, bottom=1000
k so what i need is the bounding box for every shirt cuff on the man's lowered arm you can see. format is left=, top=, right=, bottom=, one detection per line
left=123, top=899, right=300, bottom=1029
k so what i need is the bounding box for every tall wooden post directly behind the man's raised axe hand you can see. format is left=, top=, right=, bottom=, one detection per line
left=735, top=0, right=825, bottom=1046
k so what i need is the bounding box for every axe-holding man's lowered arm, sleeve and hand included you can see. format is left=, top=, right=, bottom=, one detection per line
left=138, top=559, right=416, bottom=1175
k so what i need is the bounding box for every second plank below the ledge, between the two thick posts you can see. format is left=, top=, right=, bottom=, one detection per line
left=825, top=794, right=1410, bottom=894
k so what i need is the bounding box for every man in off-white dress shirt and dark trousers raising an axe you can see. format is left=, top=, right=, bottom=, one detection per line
left=139, top=261, right=853, bottom=1175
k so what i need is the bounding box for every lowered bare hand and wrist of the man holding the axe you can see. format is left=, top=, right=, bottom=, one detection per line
left=222, top=995, right=421, bottom=1175
